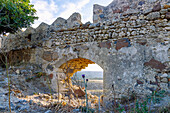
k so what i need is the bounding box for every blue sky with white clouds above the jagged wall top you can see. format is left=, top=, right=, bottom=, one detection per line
left=30, top=0, right=113, bottom=28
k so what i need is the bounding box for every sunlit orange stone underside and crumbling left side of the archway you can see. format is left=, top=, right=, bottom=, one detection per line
left=53, top=58, right=103, bottom=95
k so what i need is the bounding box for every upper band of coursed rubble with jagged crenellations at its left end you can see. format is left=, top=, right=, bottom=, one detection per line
left=2, top=1, right=170, bottom=49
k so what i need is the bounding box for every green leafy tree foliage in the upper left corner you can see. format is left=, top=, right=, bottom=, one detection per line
left=0, top=0, right=38, bottom=34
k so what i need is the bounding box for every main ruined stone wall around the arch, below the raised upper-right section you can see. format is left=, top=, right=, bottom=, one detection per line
left=2, top=0, right=170, bottom=99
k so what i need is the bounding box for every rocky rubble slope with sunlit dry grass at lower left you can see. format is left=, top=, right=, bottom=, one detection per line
left=0, top=70, right=101, bottom=113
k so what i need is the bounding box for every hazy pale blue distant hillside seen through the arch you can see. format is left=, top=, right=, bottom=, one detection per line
left=73, top=71, right=103, bottom=79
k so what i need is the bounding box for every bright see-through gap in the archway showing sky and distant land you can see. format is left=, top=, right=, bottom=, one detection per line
left=71, top=63, right=103, bottom=96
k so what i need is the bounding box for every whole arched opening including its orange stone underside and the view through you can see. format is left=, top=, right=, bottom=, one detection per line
left=59, top=58, right=103, bottom=96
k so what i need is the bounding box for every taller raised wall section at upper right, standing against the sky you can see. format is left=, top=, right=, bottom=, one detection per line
left=93, top=0, right=168, bottom=23
